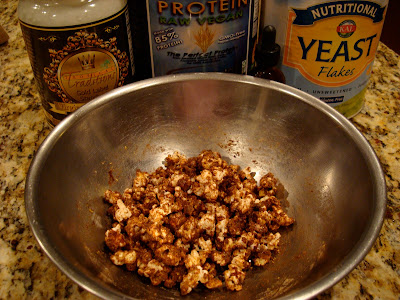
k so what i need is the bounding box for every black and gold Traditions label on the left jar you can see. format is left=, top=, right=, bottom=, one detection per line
left=20, top=6, right=135, bottom=125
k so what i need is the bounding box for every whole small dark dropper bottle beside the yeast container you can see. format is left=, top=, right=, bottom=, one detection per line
left=254, top=25, right=286, bottom=83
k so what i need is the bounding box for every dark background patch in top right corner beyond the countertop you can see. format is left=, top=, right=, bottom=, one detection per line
left=381, top=0, right=400, bottom=54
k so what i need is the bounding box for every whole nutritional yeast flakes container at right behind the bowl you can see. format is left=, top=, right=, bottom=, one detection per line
left=262, top=0, right=388, bottom=118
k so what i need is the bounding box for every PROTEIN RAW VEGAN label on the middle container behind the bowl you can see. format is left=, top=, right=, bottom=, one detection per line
left=147, top=0, right=258, bottom=77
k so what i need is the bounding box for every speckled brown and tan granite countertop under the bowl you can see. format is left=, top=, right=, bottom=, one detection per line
left=0, top=0, right=400, bottom=299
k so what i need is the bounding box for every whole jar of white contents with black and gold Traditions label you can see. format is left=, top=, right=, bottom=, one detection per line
left=18, top=0, right=135, bottom=126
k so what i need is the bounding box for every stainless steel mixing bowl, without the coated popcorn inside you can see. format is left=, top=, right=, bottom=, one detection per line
left=25, top=73, right=386, bottom=299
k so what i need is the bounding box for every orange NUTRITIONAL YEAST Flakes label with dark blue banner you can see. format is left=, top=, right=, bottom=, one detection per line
left=283, top=1, right=385, bottom=87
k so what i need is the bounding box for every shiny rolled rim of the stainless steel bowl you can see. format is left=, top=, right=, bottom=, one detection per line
left=25, top=73, right=386, bottom=300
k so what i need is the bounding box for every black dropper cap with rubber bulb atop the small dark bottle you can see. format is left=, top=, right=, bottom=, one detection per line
left=255, top=25, right=281, bottom=67
